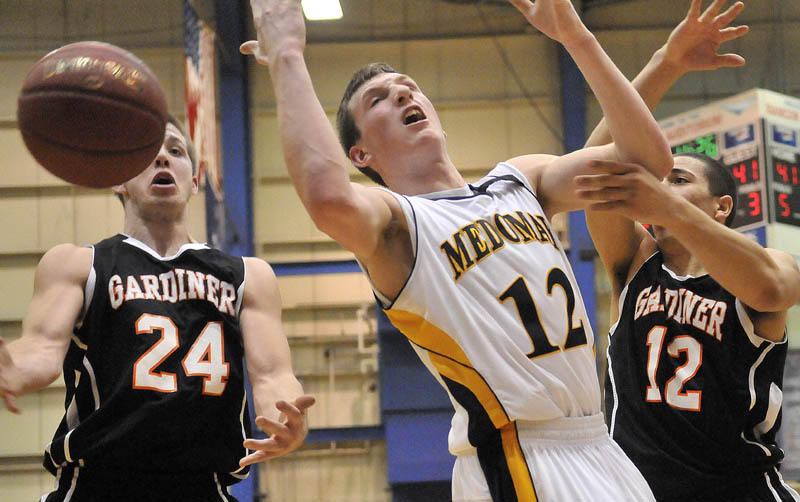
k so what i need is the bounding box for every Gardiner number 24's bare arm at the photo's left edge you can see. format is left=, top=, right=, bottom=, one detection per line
left=0, top=244, right=92, bottom=413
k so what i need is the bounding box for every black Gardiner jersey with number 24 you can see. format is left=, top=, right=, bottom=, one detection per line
left=44, top=235, right=250, bottom=484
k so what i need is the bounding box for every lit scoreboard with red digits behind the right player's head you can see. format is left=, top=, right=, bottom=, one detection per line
left=660, top=89, right=800, bottom=231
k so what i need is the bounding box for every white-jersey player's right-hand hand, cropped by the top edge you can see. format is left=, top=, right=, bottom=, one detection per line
left=509, top=0, right=591, bottom=47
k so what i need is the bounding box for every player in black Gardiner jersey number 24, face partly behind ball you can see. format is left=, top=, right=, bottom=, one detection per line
left=0, top=119, right=314, bottom=502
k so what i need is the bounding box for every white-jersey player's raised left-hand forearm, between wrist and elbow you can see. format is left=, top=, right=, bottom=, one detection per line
left=270, top=51, right=351, bottom=217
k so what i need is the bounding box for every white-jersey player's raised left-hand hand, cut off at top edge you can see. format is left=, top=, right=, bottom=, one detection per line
left=239, top=0, right=306, bottom=65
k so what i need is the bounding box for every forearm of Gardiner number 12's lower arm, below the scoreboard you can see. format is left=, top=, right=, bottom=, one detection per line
left=665, top=201, right=797, bottom=312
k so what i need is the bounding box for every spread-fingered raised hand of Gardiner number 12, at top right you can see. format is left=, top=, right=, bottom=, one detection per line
left=664, top=0, right=749, bottom=72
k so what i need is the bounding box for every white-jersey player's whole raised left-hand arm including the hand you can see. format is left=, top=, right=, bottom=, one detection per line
left=241, top=0, right=401, bottom=262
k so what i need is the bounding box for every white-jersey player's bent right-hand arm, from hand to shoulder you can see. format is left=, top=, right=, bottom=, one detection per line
left=510, top=0, right=672, bottom=214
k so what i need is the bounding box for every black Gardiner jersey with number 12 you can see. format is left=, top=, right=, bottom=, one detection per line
left=605, top=252, right=787, bottom=501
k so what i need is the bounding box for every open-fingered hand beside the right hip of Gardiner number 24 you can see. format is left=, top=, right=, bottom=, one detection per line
left=239, top=395, right=316, bottom=466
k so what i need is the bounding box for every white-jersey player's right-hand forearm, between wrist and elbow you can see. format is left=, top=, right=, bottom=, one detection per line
left=565, top=34, right=671, bottom=173
